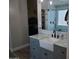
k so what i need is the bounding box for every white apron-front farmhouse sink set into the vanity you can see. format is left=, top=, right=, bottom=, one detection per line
left=39, top=38, right=59, bottom=51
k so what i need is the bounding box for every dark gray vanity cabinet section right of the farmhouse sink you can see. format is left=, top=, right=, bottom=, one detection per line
left=54, top=45, right=66, bottom=59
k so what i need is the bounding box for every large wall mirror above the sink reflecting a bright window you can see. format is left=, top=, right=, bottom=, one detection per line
left=40, top=0, right=69, bottom=31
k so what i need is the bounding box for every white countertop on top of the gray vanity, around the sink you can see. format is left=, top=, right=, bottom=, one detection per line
left=30, top=34, right=69, bottom=48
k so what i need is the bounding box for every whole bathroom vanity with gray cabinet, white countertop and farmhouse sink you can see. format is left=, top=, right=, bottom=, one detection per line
left=30, top=34, right=68, bottom=59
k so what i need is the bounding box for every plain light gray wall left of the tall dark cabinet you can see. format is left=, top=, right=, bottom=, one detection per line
left=9, top=0, right=29, bottom=49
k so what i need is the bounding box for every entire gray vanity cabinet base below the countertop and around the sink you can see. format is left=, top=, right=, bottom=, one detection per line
left=30, top=38, right=67, bottom=59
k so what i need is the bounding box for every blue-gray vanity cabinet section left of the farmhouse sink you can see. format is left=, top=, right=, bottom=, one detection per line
left=30, top=38, right=41, bottom=59
